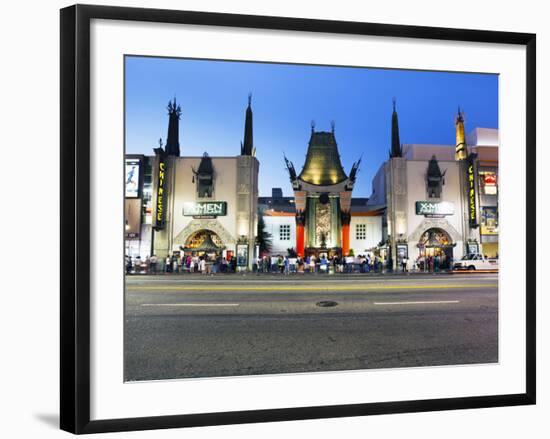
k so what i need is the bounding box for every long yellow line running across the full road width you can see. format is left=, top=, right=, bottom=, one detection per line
left=126, top=283, right=498, bottom=293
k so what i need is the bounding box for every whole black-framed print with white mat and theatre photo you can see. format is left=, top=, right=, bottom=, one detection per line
left=61, top=5, right=536, bottom=433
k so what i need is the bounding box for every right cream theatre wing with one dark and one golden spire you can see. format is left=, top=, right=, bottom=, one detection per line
left=369, top=107, right=498, bottom=268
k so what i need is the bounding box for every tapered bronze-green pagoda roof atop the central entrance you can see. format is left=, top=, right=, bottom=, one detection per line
left=298, top=131, right=348, bottom=186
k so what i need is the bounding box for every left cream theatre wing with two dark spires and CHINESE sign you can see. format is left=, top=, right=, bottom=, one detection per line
left=126, top=98, right=259, bottom=269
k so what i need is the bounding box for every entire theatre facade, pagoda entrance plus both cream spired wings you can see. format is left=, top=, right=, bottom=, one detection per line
left=125, top=97, right=499, bottom=270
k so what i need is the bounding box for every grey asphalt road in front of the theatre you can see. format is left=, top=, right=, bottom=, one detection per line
left=124, top=274, right=498, bottom=381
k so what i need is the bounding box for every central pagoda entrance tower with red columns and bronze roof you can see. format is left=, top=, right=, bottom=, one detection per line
left=285, top=123, right=361, bottom=256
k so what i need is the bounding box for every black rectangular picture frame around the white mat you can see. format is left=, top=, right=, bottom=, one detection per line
left=60, top=5, right=536, bottom=434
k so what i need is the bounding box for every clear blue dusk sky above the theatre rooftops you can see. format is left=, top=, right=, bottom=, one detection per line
left=125, top=56, right=498, bottom=197
